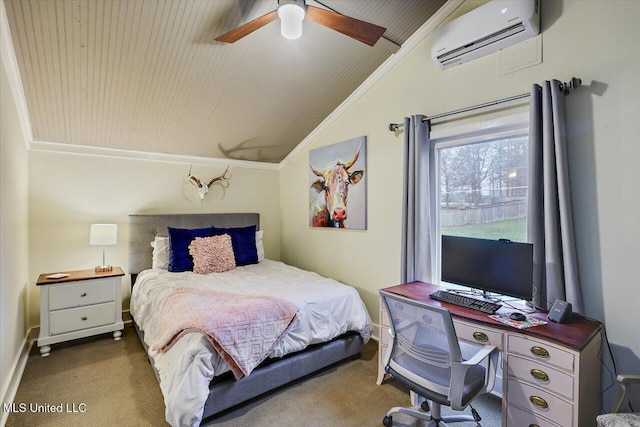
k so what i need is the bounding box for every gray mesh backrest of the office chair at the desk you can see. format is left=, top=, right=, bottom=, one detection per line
left=380, top=291, right=462, bottom=395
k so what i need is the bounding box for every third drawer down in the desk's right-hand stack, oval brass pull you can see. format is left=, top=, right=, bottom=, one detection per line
left=507, top=378, right=573, bottom=426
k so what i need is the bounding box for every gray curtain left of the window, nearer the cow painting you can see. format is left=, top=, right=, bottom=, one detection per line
left=401, top=115, right=435, bottom=283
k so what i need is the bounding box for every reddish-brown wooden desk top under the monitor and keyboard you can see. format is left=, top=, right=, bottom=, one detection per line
left=383, top=282, right=602, bottom=350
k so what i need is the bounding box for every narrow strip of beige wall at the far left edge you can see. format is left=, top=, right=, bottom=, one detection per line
left=0, top=38, right=29, bottom=402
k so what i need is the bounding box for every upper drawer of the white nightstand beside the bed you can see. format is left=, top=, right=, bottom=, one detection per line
left=49, top=279, right=114, bottom=310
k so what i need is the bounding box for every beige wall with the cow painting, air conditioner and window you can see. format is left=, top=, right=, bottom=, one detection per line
left=280, top=0, right=640, bottom=398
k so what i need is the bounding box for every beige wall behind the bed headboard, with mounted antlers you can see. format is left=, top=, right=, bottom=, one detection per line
left=29, top=150, right=280, bottom=326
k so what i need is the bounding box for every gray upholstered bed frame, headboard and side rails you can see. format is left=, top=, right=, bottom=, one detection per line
left=129, top=213, right=363, bottom=419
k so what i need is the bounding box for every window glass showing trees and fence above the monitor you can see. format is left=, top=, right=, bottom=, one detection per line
left=438, top=136, right=529, bottom=242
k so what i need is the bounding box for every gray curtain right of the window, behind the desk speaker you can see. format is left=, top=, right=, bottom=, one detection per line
left=527, top=80, right=582, bottom=313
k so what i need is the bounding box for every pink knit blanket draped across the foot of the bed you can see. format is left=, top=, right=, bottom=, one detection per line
left=152, top=288, right=298, bottom=379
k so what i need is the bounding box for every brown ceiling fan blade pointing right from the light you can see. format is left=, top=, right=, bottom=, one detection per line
left=306, top=5, right=387, bottom=46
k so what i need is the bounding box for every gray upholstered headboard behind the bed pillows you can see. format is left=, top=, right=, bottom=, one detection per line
left=129, top=213, right=260, bottom=284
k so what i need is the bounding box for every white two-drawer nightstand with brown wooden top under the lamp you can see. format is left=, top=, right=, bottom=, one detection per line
left=36, top=267, right=124, bottom=357
